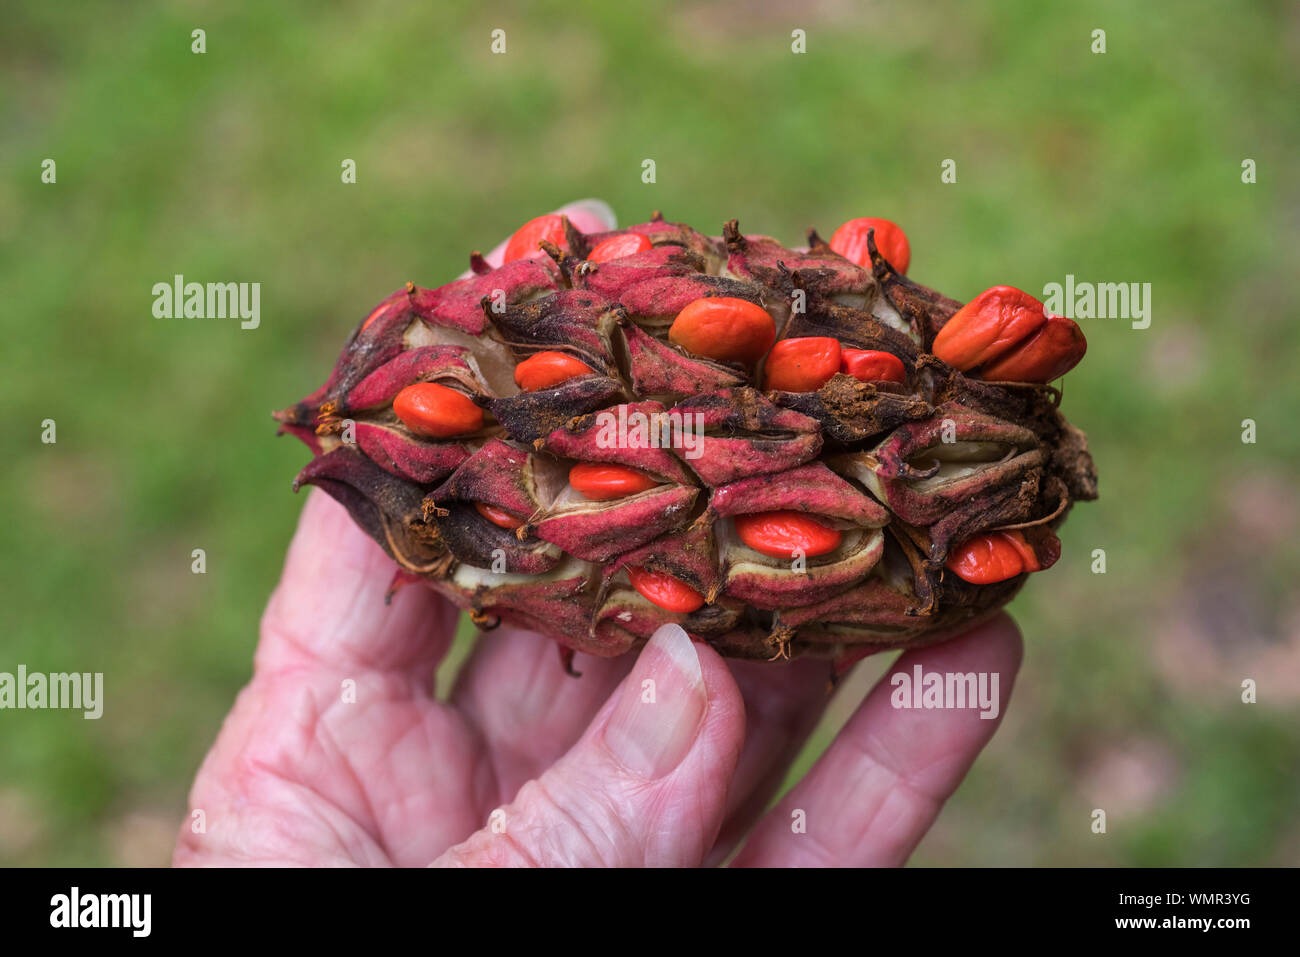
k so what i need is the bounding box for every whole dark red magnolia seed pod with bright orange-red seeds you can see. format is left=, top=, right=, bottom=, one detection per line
left=276, top=213, right=1097, bottom=672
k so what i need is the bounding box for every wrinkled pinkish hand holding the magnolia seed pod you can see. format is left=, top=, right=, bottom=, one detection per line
left=174, top=201, right=1022, bottom=866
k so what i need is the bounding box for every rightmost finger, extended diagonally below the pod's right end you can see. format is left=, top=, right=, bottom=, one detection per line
left=736, top=615, right=1023, bottom=867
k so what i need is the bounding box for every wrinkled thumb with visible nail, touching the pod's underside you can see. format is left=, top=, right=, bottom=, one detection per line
left=433, top=624, right=745, bottom=867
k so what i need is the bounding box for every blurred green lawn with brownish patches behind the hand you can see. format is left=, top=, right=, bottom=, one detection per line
left=0, top=0, right=1300, bottom=865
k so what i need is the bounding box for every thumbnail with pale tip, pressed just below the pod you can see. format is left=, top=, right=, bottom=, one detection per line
left=605, top=624, right=707, bottom=780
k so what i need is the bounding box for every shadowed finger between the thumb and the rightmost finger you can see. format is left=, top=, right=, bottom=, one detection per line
left=705, top=658, right=831, bottom=865
